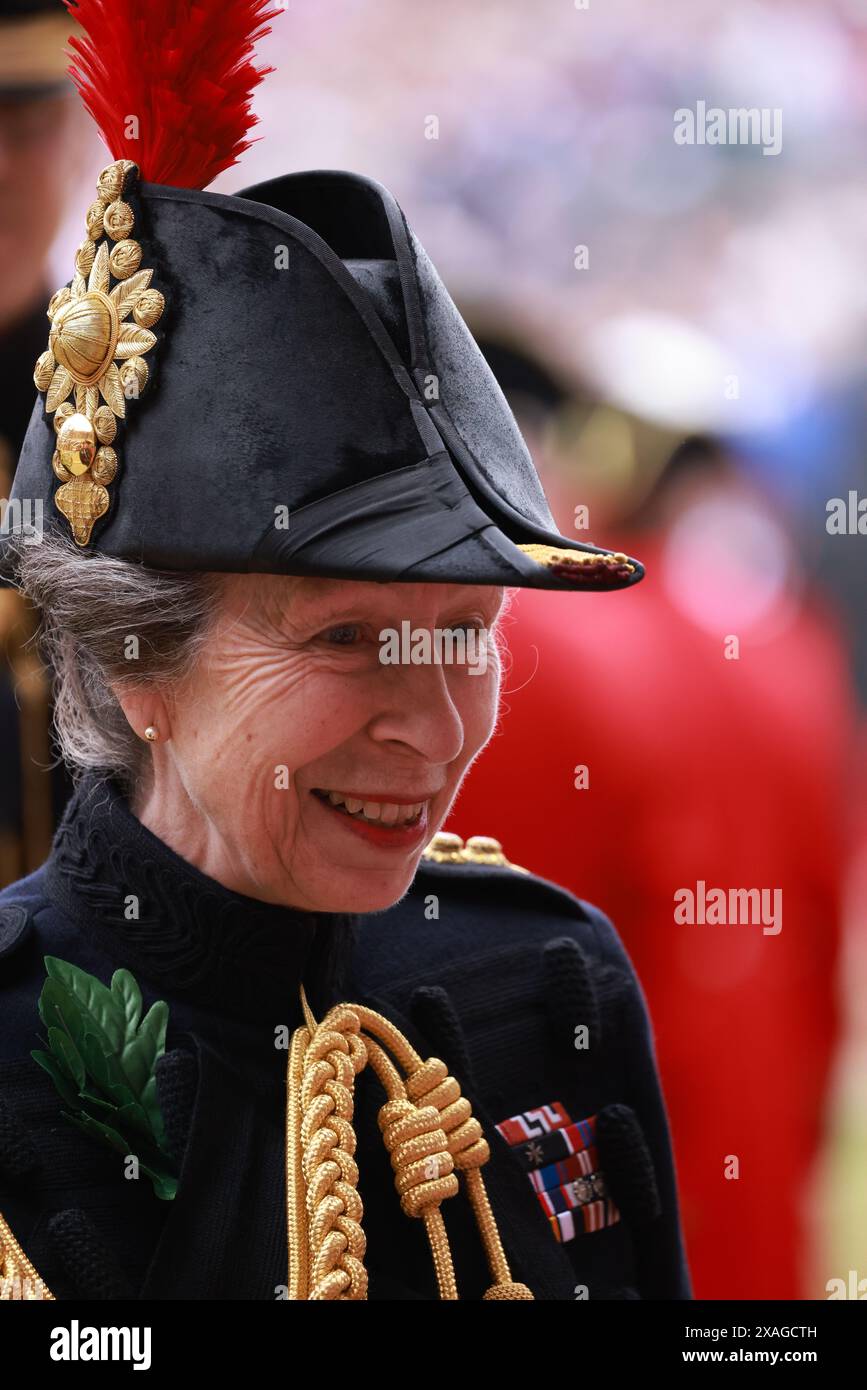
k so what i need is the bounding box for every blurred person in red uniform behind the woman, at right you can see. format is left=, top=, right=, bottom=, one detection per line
left=447, top=343, right=854, bottom=1298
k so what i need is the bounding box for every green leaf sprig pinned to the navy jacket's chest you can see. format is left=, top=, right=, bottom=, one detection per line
left=31, top=956, right=178, bottom=1200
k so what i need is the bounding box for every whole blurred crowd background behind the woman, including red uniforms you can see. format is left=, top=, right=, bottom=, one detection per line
left=0, top=0, right=867, bottom=1298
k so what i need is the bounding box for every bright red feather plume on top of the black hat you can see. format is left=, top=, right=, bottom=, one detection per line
left=64, top=0, right=282, bottom=188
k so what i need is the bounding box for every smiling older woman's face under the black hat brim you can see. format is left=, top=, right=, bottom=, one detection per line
left=136, top=575, right=504, bottom=912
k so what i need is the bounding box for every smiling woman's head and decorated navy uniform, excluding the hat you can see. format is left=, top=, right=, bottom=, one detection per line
left=0, top=522, right=689, bottom=1300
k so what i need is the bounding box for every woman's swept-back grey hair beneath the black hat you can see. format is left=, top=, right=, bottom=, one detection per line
left=5, top=535, right=221, bottom=792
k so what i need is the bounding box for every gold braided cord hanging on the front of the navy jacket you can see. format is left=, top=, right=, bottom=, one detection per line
left=286, top=986, right=534, bottom=1300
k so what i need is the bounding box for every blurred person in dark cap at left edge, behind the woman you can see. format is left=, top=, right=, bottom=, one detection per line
left=0, top=0, right=81, bottom=887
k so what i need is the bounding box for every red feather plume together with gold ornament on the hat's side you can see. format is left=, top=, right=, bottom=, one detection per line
left=27, top=0, right=279, bottom=546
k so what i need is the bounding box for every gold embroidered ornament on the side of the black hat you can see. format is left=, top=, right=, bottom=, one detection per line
left=33, top=160, right=164, bottom=545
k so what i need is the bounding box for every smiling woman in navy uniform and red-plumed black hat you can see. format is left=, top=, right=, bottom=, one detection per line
left=0, top=0, right=689, bottom=1301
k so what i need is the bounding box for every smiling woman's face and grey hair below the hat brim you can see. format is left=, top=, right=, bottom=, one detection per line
left=10, top=537, right=503, bottom=912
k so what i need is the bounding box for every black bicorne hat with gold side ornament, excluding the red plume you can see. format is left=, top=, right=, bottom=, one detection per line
left=1, top=1, right=643, bottom=589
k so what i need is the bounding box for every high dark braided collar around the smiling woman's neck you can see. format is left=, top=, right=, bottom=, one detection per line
left=46, top=773, right=357, bottom=1017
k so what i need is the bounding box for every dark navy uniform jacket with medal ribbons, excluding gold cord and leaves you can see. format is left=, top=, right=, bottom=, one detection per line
left=0, top=776, right=691, bottom=1300
